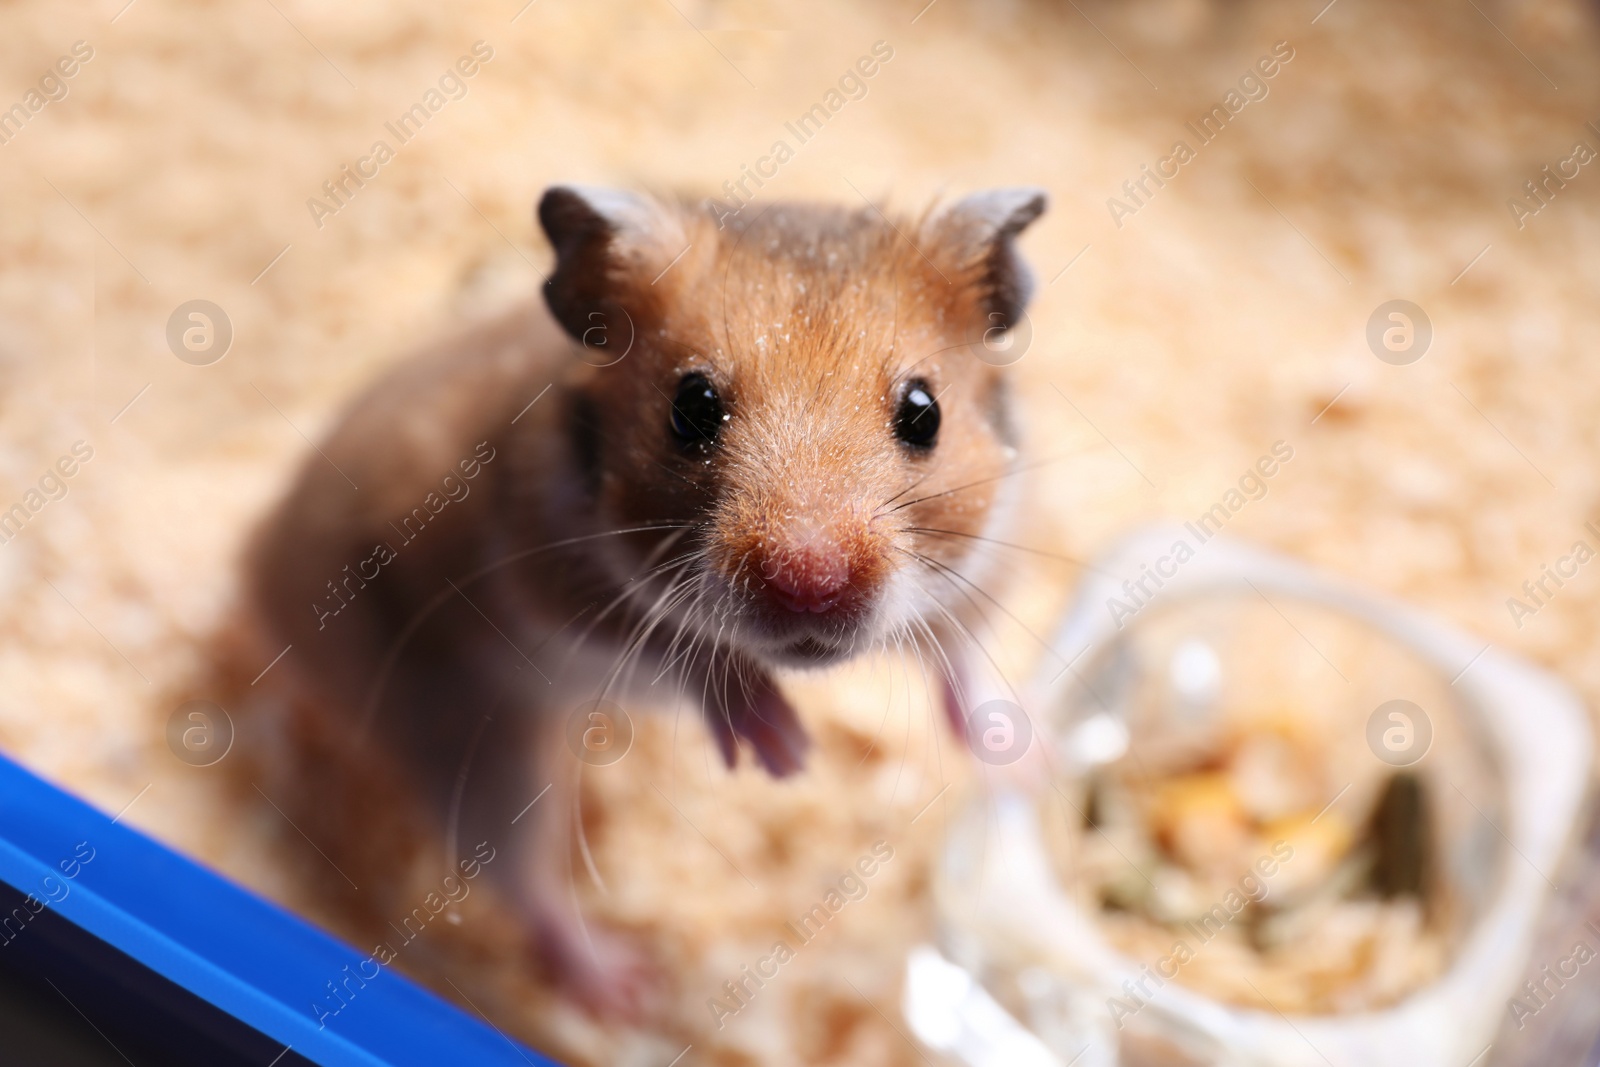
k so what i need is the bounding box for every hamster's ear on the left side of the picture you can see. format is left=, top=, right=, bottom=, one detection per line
left=538, top=186, right=682, bottom=341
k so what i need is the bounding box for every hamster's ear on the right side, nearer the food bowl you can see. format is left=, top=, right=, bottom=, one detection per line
left=931, top=187, right=1046, bottom=330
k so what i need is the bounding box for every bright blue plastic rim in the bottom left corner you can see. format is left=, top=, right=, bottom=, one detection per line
left=0, top=757, right=558, bottom=1067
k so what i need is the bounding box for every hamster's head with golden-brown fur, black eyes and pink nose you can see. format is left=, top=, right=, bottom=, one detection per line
left=539, top=187, right=1045, bottom=667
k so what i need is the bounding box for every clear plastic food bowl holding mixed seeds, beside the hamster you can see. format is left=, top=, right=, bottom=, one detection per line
left=907, top=530, right=1592, bottom=1067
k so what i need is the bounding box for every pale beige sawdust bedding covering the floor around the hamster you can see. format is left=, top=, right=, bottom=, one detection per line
left=0, top=0, right=1600, bottom=1064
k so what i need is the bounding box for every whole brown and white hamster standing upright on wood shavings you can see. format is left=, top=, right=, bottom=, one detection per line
left=245, top=187, right=1045, bottom=1013
